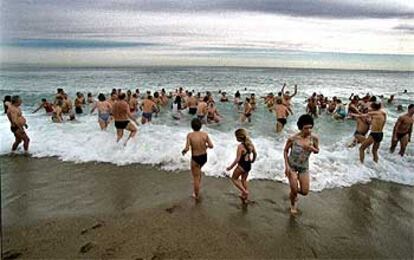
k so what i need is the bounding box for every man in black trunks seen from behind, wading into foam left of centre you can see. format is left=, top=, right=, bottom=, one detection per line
left=112, top=93, right=138, bottom=145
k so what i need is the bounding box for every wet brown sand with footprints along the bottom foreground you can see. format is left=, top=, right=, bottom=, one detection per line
left=0, top=156, right=414, bottom=259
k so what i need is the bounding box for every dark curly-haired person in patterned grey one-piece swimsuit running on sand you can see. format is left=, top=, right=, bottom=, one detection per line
left=284, top=114, right=319, bottom=214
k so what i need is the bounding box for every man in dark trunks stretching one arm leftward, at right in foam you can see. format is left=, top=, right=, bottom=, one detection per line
left=351, top=102, right=387, bottom=163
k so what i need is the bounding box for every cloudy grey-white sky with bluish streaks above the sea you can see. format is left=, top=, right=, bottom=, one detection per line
left=0, top=0, right=414, bottom=71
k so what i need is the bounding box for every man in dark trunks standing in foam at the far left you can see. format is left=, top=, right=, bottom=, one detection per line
left=7, top=96, right=30, bottom=153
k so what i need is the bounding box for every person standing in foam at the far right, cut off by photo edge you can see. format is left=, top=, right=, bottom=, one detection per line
left=390, top=104, right=414, bottom=156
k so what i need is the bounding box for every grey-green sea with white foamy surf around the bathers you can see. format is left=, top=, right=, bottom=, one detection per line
left=0, top=67, right=414, bottom=191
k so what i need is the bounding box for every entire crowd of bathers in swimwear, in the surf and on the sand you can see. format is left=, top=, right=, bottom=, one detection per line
left=4, top=85, right=414, bottom=214
